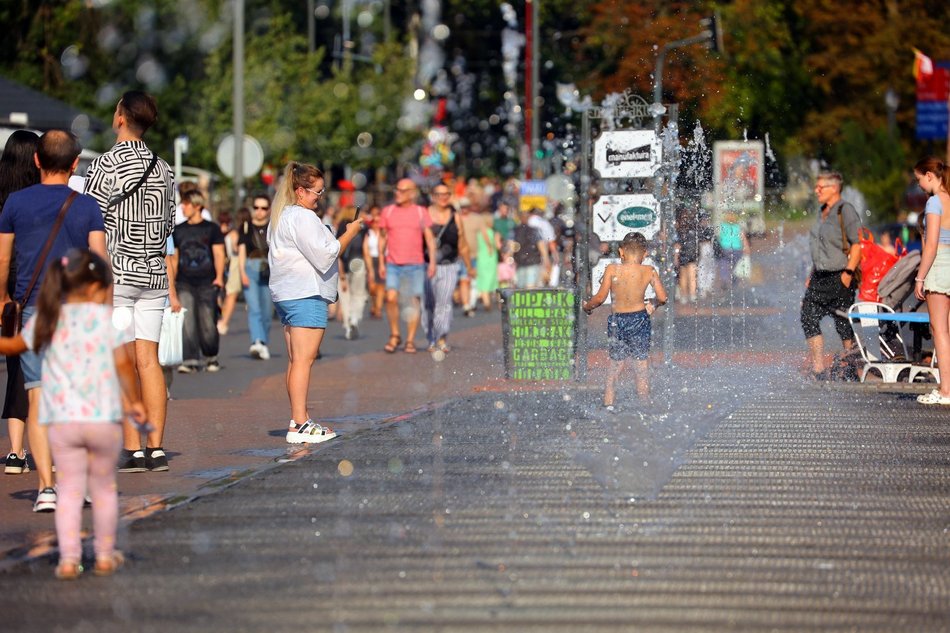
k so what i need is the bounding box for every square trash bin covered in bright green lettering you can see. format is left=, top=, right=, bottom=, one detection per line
left=498, top=288, right=577, bottom=380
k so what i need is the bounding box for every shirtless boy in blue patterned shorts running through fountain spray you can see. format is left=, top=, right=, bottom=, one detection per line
left=581, top=233, right=666, bottom=412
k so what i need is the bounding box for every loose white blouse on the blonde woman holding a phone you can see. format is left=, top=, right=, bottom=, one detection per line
left=267, top=205, right=340, bottom=302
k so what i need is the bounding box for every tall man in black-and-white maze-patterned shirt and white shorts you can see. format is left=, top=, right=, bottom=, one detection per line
left=86, top=91, right=175, bottom=472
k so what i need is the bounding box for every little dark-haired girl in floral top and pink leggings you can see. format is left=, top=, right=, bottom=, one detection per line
left=0, top=249, right=145, bottom=580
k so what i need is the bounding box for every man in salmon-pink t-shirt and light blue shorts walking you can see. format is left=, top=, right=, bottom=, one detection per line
left=377, top=178, right=436, bottom=354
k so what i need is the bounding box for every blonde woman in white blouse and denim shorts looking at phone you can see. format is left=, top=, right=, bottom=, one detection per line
left=267, top=162, right=362, bottom=444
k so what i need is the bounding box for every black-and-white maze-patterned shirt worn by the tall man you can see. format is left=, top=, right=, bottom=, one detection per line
left=86, top=141, right=175, bottom=290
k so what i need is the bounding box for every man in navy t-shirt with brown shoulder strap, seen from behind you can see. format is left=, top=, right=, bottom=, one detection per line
left=0, top=130, right=108, bottom=512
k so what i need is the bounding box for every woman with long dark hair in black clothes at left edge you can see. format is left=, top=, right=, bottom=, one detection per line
left=0, top=130, right=40, bottom=475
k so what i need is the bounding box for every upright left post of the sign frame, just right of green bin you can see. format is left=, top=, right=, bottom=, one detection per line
left=574, top=109, right=591, bottom=381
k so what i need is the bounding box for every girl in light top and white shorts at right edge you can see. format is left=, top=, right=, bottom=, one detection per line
left=914, top=156, right=950, bottom=405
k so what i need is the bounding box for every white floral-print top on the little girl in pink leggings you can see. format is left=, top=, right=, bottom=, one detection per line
left=21, top=303, right=131, bottom=424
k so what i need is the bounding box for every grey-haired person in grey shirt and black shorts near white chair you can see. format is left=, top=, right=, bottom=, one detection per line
left=801, top=172, right=861, bottom=380
